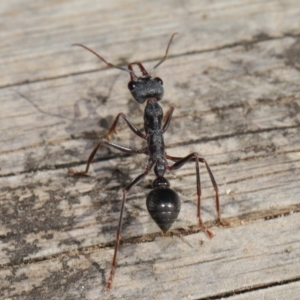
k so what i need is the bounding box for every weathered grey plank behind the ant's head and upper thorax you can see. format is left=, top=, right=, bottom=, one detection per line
left=0, top=38, right=300, bottom=175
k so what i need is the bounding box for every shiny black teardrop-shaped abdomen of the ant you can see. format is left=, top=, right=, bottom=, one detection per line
left=146, top=187, right=181, bottom=232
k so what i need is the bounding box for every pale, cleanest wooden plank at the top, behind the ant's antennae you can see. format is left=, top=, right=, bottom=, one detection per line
left=0, top=0, right=300, bottom=87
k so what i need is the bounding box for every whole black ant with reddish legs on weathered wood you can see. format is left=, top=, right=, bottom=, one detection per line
left=69, top=33, right=224, bottom=290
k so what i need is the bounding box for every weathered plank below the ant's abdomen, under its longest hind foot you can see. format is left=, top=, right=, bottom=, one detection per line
left=0, top=214, right=300, bottom=300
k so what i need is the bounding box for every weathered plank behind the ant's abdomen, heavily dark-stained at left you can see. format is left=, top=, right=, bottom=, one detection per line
left=0, top=146, right=300, bottom=265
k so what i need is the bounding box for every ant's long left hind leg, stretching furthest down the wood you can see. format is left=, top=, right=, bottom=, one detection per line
left=106, top=161, right=154, bottom=290
